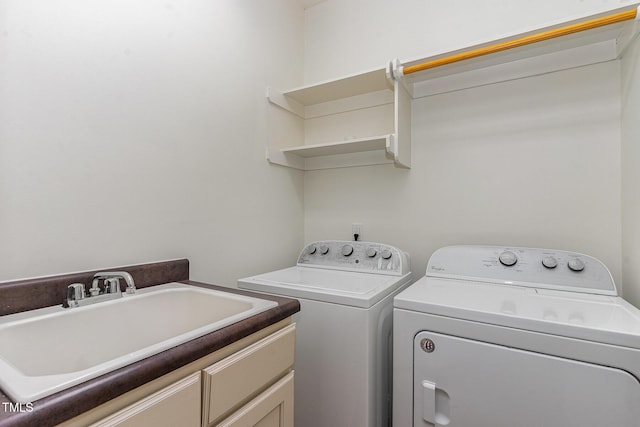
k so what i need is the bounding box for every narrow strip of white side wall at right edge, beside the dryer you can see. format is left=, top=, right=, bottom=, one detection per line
left=622, top=35, right=640, bottom=306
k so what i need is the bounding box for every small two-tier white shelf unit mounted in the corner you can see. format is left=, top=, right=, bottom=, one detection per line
left=267, top=69, right=411, bottom=170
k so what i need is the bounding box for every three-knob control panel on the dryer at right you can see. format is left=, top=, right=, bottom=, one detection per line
left=427, top=246, right=618, bottom=295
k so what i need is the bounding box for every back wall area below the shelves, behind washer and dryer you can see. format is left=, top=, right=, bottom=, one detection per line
left=305, top=63, right=620, bottom=288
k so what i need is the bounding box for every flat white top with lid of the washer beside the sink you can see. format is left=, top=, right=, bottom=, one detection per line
left=238, top=266, right=410, bottom=308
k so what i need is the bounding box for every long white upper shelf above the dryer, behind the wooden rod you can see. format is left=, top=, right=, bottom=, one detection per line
left=393, top=2, right=640, bottom=98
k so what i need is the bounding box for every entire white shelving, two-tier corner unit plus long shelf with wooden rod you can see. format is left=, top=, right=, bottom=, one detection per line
left=267, top=2, right=640, bottom=170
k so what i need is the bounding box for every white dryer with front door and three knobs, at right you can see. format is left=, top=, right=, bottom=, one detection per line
left=393, top=246, right=640, bottom=427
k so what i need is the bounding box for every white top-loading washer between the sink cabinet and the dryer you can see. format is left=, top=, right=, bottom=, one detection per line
left=238, top=241, right=411, bottom=427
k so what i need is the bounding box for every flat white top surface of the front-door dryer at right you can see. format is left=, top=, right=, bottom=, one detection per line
left=394, top=277, right=640, bottom=349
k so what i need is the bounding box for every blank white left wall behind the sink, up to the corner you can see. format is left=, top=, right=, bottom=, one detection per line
left=0, top=0, right=303, bottom=285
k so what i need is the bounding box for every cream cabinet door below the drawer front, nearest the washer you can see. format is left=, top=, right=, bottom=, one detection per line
left=217, top=371, right=293, bottom=427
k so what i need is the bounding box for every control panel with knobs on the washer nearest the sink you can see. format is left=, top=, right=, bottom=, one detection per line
left=298, top=240, right=410, bottom=276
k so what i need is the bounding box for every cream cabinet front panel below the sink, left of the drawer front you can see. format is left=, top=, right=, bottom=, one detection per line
left=92, top=372, right=201, bottom=427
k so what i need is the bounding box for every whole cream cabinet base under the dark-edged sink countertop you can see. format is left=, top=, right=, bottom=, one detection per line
left=60, top=318, right=296, bottom=427
